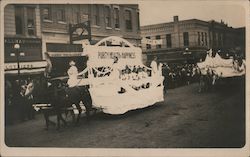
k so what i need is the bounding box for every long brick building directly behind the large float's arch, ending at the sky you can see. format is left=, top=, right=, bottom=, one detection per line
left=40, top=4, right=140, bottom=75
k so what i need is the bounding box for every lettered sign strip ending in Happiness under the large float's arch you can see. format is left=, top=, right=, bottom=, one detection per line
left=98, top=52, right=136, bottom=59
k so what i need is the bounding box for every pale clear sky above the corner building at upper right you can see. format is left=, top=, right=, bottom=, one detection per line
left=139, top=0, right=246, bottom=28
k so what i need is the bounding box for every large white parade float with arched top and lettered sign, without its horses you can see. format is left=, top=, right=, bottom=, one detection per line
left=70, top=36, right=164, bottom=114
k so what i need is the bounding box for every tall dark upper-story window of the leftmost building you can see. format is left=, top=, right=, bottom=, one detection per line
left=15, top=6, right=36, bottom=36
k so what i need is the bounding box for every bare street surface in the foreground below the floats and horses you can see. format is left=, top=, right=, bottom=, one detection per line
left=5, top=79, right=245, bottom=148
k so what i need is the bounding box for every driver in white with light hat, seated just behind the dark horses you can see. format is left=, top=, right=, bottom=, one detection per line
left=67, top=60, right=78, bottom=87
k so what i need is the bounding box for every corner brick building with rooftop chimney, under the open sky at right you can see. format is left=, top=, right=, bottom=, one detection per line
left=141, top=16, right=245, bottom=62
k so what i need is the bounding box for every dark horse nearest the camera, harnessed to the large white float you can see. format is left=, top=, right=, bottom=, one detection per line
left=43, top=80, right=92, bottom=130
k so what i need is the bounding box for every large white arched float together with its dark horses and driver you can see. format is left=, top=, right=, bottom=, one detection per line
left=34, top=36, right=164, bottom=129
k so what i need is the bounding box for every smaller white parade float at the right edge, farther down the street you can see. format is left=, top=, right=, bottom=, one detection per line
left=197, top=50, right=246, bottom=78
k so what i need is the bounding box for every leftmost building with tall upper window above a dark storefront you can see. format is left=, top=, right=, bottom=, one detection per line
left=4, top=5, right=42, bottom=70
